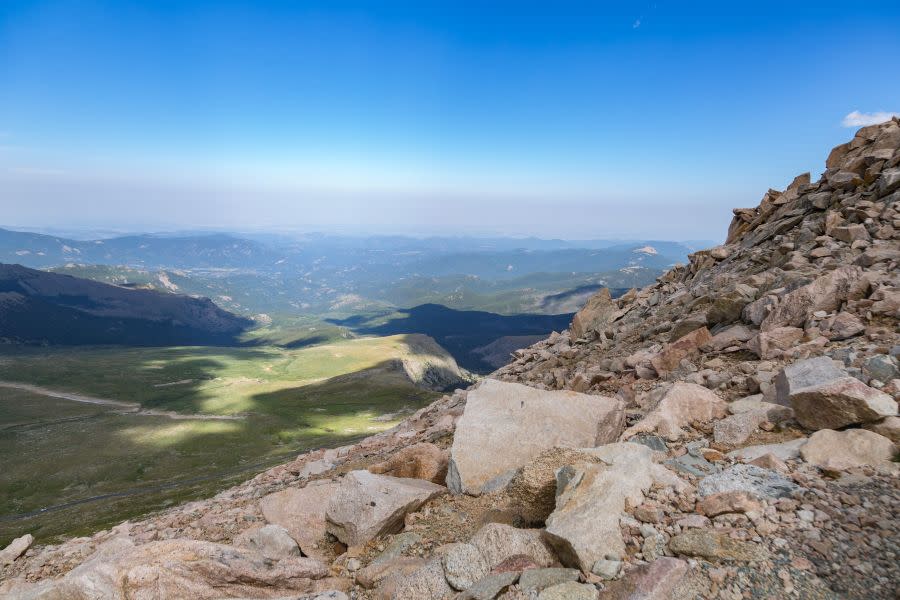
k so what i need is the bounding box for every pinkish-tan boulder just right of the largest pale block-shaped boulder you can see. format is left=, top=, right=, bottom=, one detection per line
left=622, top=382, right=727, bottom=439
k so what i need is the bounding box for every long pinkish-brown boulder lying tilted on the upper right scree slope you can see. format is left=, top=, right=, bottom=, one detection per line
left=760, top=266, right=869, bottom=331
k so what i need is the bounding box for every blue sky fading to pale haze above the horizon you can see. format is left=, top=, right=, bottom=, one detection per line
left=0, top=0, right=900, bottom=239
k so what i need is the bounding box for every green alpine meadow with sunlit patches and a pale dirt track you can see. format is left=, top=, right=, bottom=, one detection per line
left=0, top=336, right=454, bottom=546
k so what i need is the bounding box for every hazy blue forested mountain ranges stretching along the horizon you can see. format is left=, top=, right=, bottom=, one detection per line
left=0, top=229, right=711, bottom=318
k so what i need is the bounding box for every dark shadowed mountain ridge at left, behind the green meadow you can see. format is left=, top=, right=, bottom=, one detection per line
left=0, top=264, right=252, bottom=346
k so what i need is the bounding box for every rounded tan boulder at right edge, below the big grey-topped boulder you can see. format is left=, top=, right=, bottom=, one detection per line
left=800, top=429, right=897, bottom=471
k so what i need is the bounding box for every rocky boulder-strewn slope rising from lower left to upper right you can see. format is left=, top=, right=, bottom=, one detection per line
left=0, top=119, right=900, bottom=600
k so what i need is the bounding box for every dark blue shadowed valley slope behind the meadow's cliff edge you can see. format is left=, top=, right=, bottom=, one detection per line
left=328, top=304, right=572, bottom=374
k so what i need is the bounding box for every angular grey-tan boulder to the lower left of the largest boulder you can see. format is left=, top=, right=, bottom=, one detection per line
left=325, top=471, right=446, bottom=546
